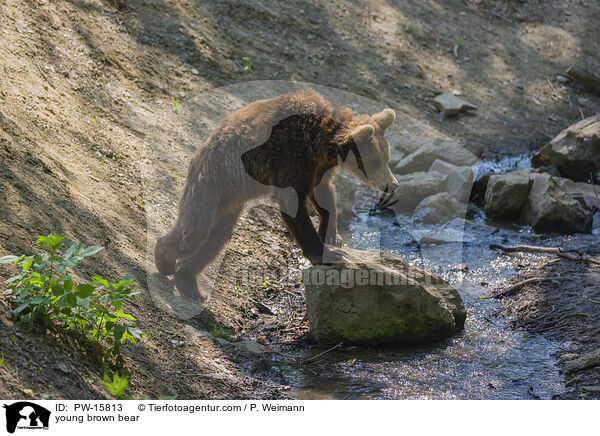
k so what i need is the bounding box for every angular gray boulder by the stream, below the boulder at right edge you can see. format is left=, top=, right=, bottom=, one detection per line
left=516, top=174, right=593, bottom=233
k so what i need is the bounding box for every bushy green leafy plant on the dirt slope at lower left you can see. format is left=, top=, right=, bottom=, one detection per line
left=0, top=235, right=142, bottom=367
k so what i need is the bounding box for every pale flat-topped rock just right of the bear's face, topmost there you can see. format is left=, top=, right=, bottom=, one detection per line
left=394, top=138, right=479, bottom=175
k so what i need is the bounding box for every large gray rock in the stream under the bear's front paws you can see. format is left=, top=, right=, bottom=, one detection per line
left=303, top=248, right=466, bottom=345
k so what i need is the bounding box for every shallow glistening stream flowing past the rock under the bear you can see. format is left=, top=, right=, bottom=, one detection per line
left=280, top=157, right=600, bottom=399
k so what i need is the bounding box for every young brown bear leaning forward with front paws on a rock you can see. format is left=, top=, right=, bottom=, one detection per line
left=154, top=90, right=398, bottom=299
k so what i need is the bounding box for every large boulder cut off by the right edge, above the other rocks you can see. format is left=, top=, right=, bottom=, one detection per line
left=532, top=114, right=600, bottom=182
